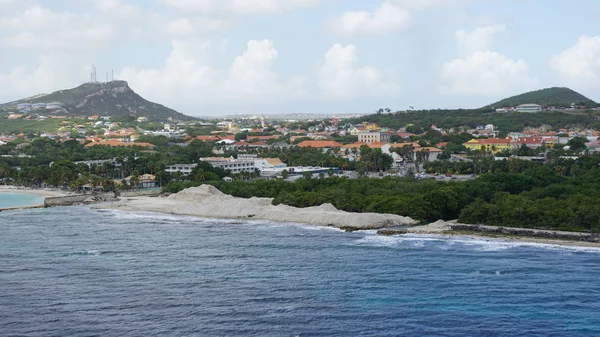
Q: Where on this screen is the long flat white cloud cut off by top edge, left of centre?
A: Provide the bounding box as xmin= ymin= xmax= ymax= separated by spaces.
xmin=160 ymin=0 xmax=321 ymax=15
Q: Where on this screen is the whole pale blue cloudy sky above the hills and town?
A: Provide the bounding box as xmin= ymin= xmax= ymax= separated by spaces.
xmin=0 ymin=0 xmax=600 ymax=116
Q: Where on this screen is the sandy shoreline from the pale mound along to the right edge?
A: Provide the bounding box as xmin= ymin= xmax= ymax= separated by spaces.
xmin=94 ymin=185 xmax=600 ymax=247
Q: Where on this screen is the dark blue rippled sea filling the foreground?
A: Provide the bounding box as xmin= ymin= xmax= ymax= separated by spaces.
xmin=0 ymin=207 xmax=600 ymax=336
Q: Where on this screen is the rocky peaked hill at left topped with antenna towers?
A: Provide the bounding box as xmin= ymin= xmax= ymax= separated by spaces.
xmin=4 ymin=81 xmax=193 ymax=121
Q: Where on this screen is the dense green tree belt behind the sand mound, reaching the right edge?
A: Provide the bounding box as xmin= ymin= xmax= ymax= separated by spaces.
xmin=166 ymin=155 xmax=600 ymax=232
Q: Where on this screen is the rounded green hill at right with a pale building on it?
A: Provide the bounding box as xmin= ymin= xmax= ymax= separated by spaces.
xmin=486 ymin=87 xmax=598 ymax=108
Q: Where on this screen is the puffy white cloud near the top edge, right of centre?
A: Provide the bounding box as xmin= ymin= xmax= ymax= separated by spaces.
xmin=329 ymin=1 xmax=410 ymax=35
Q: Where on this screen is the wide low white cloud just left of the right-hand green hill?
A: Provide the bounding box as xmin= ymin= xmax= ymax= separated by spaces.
xmin=440 ymin=51 xmax=537 ymax=97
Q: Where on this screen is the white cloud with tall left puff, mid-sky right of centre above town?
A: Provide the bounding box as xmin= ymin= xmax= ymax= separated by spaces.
xmin=318 ymin=44 xmax=400 ymax=98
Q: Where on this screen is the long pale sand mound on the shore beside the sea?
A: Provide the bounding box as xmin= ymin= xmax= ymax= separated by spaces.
xmin=99 ymin=185 xmax=416 ymax=229
